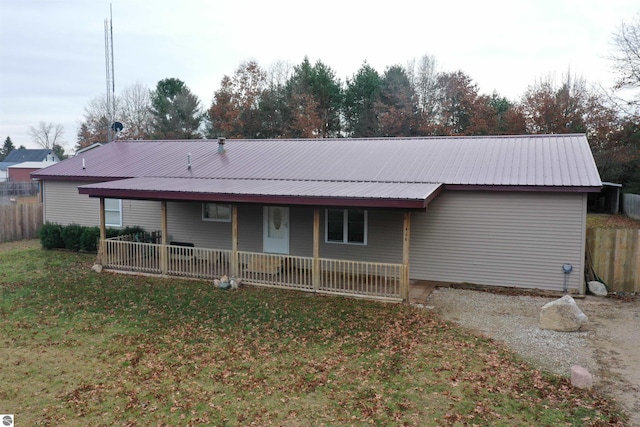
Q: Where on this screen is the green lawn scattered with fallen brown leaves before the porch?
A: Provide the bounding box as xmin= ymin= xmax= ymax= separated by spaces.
xmin=0 ymin=245 xmax=624 ymax=426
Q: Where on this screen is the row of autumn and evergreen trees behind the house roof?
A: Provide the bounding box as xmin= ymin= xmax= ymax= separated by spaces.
xmin=47 ymin=14 xmax=640 ymax=191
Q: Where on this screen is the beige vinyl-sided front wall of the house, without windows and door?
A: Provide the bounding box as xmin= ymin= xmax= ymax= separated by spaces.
xmin=43 ymin=181 xmax=587 ymax=292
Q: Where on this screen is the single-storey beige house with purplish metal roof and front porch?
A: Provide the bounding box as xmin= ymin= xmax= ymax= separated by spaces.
xmin=32 ymin=134 xmax=602 ymax=299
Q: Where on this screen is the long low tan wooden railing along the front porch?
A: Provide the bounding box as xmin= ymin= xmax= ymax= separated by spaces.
xmin=102 ymin=238 xmax=408 ymax=301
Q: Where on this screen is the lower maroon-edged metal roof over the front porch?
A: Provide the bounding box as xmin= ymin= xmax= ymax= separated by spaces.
xmin=78 ymin=177 xmax=442 ymax=209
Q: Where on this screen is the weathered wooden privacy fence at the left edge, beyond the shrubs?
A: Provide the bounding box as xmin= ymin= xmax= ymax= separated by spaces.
xmin=0 ymin=203 xmax=42 ymax=242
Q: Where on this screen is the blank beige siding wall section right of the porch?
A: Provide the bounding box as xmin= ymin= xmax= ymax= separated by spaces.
xmin=410 ymin=191 xmax=586 ymax=292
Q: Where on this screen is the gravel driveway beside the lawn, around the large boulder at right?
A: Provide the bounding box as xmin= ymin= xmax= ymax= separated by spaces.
xmin=425 ymin=288 xmax=640 ymax=426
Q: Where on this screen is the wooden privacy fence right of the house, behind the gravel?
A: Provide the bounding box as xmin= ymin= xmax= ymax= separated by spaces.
xmin=587 ymin=228 xmax=640 ymax=292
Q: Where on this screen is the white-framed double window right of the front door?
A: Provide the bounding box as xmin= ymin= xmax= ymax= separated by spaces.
xmin=325 ymin=209 xmax=367 ymax=245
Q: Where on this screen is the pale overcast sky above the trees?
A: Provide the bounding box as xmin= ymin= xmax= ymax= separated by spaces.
xmin=0 ymin=0 xmax=640 ymax=152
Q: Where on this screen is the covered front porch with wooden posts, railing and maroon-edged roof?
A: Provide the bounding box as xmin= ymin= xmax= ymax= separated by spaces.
xmin=80 ymin=180 xmax=439 ymax=302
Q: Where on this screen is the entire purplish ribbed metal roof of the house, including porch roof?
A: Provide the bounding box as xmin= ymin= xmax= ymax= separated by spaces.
xmin=32 ymin=134 xmax=602 ymax=207
